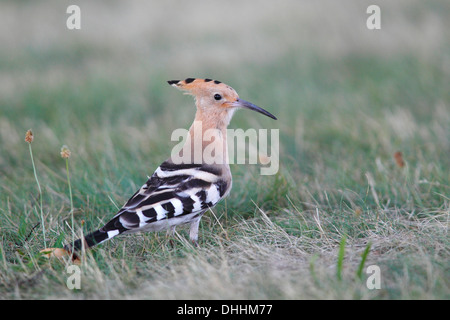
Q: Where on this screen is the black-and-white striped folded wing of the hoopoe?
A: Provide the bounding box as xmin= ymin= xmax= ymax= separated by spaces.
xmin=99 ymin=161 xmax=231 ymax=242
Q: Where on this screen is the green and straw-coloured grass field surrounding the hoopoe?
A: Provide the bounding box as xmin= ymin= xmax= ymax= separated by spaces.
xmin=0 ymin=2 xmax=450 ymax=299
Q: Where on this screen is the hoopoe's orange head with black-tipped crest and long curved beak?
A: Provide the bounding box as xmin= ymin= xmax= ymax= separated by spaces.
xmin=167 ymin=78 xmax=277 ymax=120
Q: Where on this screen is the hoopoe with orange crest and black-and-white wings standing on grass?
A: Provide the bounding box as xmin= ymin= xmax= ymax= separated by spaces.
xmin=64 ymin=78 xmax=276 ymax=253
